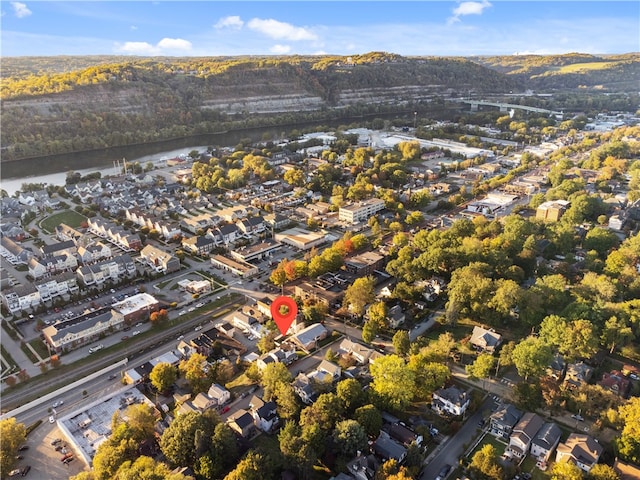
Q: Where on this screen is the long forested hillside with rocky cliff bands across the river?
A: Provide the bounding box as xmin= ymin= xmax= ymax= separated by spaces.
xmin=0 ymin=52 xmax=640 ymax=161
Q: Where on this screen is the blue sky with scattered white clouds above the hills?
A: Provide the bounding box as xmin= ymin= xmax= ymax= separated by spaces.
xmin=0 ymin=0 xmax=640 ymax=56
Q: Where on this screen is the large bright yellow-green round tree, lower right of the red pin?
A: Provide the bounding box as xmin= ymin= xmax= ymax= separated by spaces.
xmin=370 ymin=355 xmax=416 ymax=409
